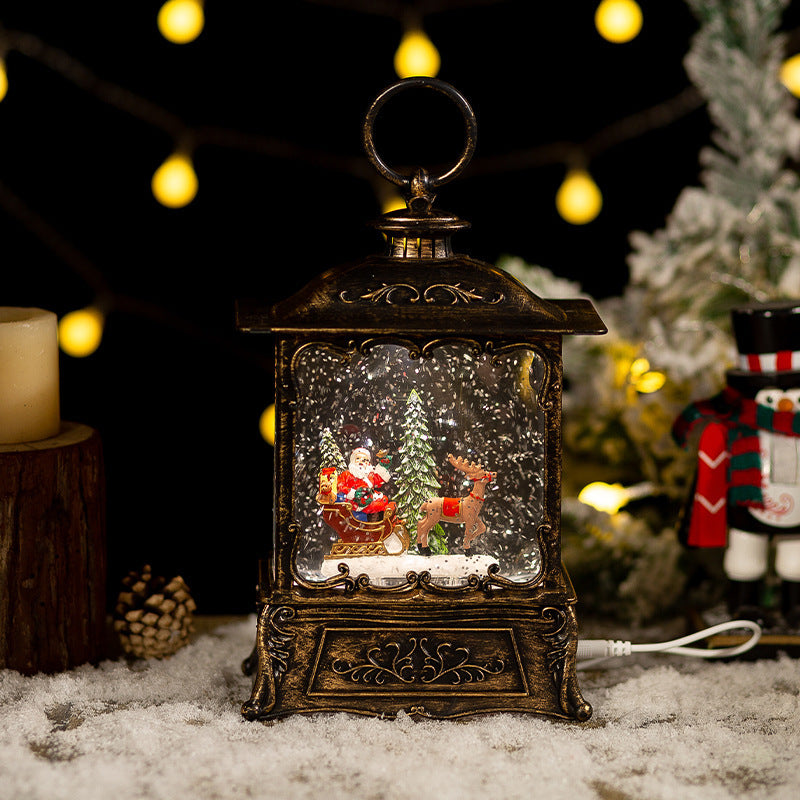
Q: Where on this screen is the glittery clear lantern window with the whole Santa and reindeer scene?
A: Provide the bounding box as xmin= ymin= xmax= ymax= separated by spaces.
xmin=294 ymin=343 xmax=545 ymax=586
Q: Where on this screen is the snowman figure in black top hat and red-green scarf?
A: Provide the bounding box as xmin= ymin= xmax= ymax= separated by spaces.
xmin=673 ymin=301 xmax=800 ymax=628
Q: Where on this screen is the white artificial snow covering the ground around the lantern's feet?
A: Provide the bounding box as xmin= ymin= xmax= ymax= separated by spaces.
xmin=0 ymin=617 xmax=800 ymax=800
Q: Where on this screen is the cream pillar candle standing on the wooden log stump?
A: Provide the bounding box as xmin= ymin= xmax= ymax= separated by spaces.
xmin=0 ymin=306 xmax=61 ymax=444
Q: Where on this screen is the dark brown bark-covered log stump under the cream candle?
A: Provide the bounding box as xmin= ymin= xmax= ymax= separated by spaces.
xmin=0 ymin=422 xmax=106 ymax=675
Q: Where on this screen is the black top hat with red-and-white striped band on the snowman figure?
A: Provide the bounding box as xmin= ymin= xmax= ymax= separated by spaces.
xmin=727 ymin=300 xmax=800 ymax=394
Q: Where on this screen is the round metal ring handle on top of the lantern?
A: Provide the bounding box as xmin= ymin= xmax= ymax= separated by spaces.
xmin=364 ymin=77 xmax=478 ymax=189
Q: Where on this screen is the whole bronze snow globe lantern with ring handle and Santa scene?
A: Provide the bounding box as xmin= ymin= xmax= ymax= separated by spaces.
xmin=238 ymin=78 xmax=605 ymax=720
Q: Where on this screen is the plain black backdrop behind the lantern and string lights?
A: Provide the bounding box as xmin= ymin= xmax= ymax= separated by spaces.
xmin=0 ymin=0 xmax=792 ymax=613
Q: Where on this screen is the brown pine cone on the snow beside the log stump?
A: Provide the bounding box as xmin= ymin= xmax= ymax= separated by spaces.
xmin=114 ymin=565 xmax=197 ymax=658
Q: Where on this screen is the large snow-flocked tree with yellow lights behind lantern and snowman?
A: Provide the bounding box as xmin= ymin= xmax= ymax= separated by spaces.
xmin=501 ymin=0 xmax=800 ymax=620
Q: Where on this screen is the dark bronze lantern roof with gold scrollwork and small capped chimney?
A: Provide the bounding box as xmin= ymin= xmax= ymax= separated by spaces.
xmin=237 ymin=225 xmax=606 ymax=336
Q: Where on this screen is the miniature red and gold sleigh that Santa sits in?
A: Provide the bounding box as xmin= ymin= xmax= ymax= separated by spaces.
xmin=317 ymin=467 xmax=410 ymax=559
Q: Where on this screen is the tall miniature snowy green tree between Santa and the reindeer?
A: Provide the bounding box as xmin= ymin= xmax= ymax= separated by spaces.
xmin=394 ymin=389 xmax=448 ymax=555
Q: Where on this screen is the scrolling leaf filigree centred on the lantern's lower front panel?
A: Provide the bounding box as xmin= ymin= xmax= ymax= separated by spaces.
xmin=331 ymin=636 xmax=506 ymax=686
